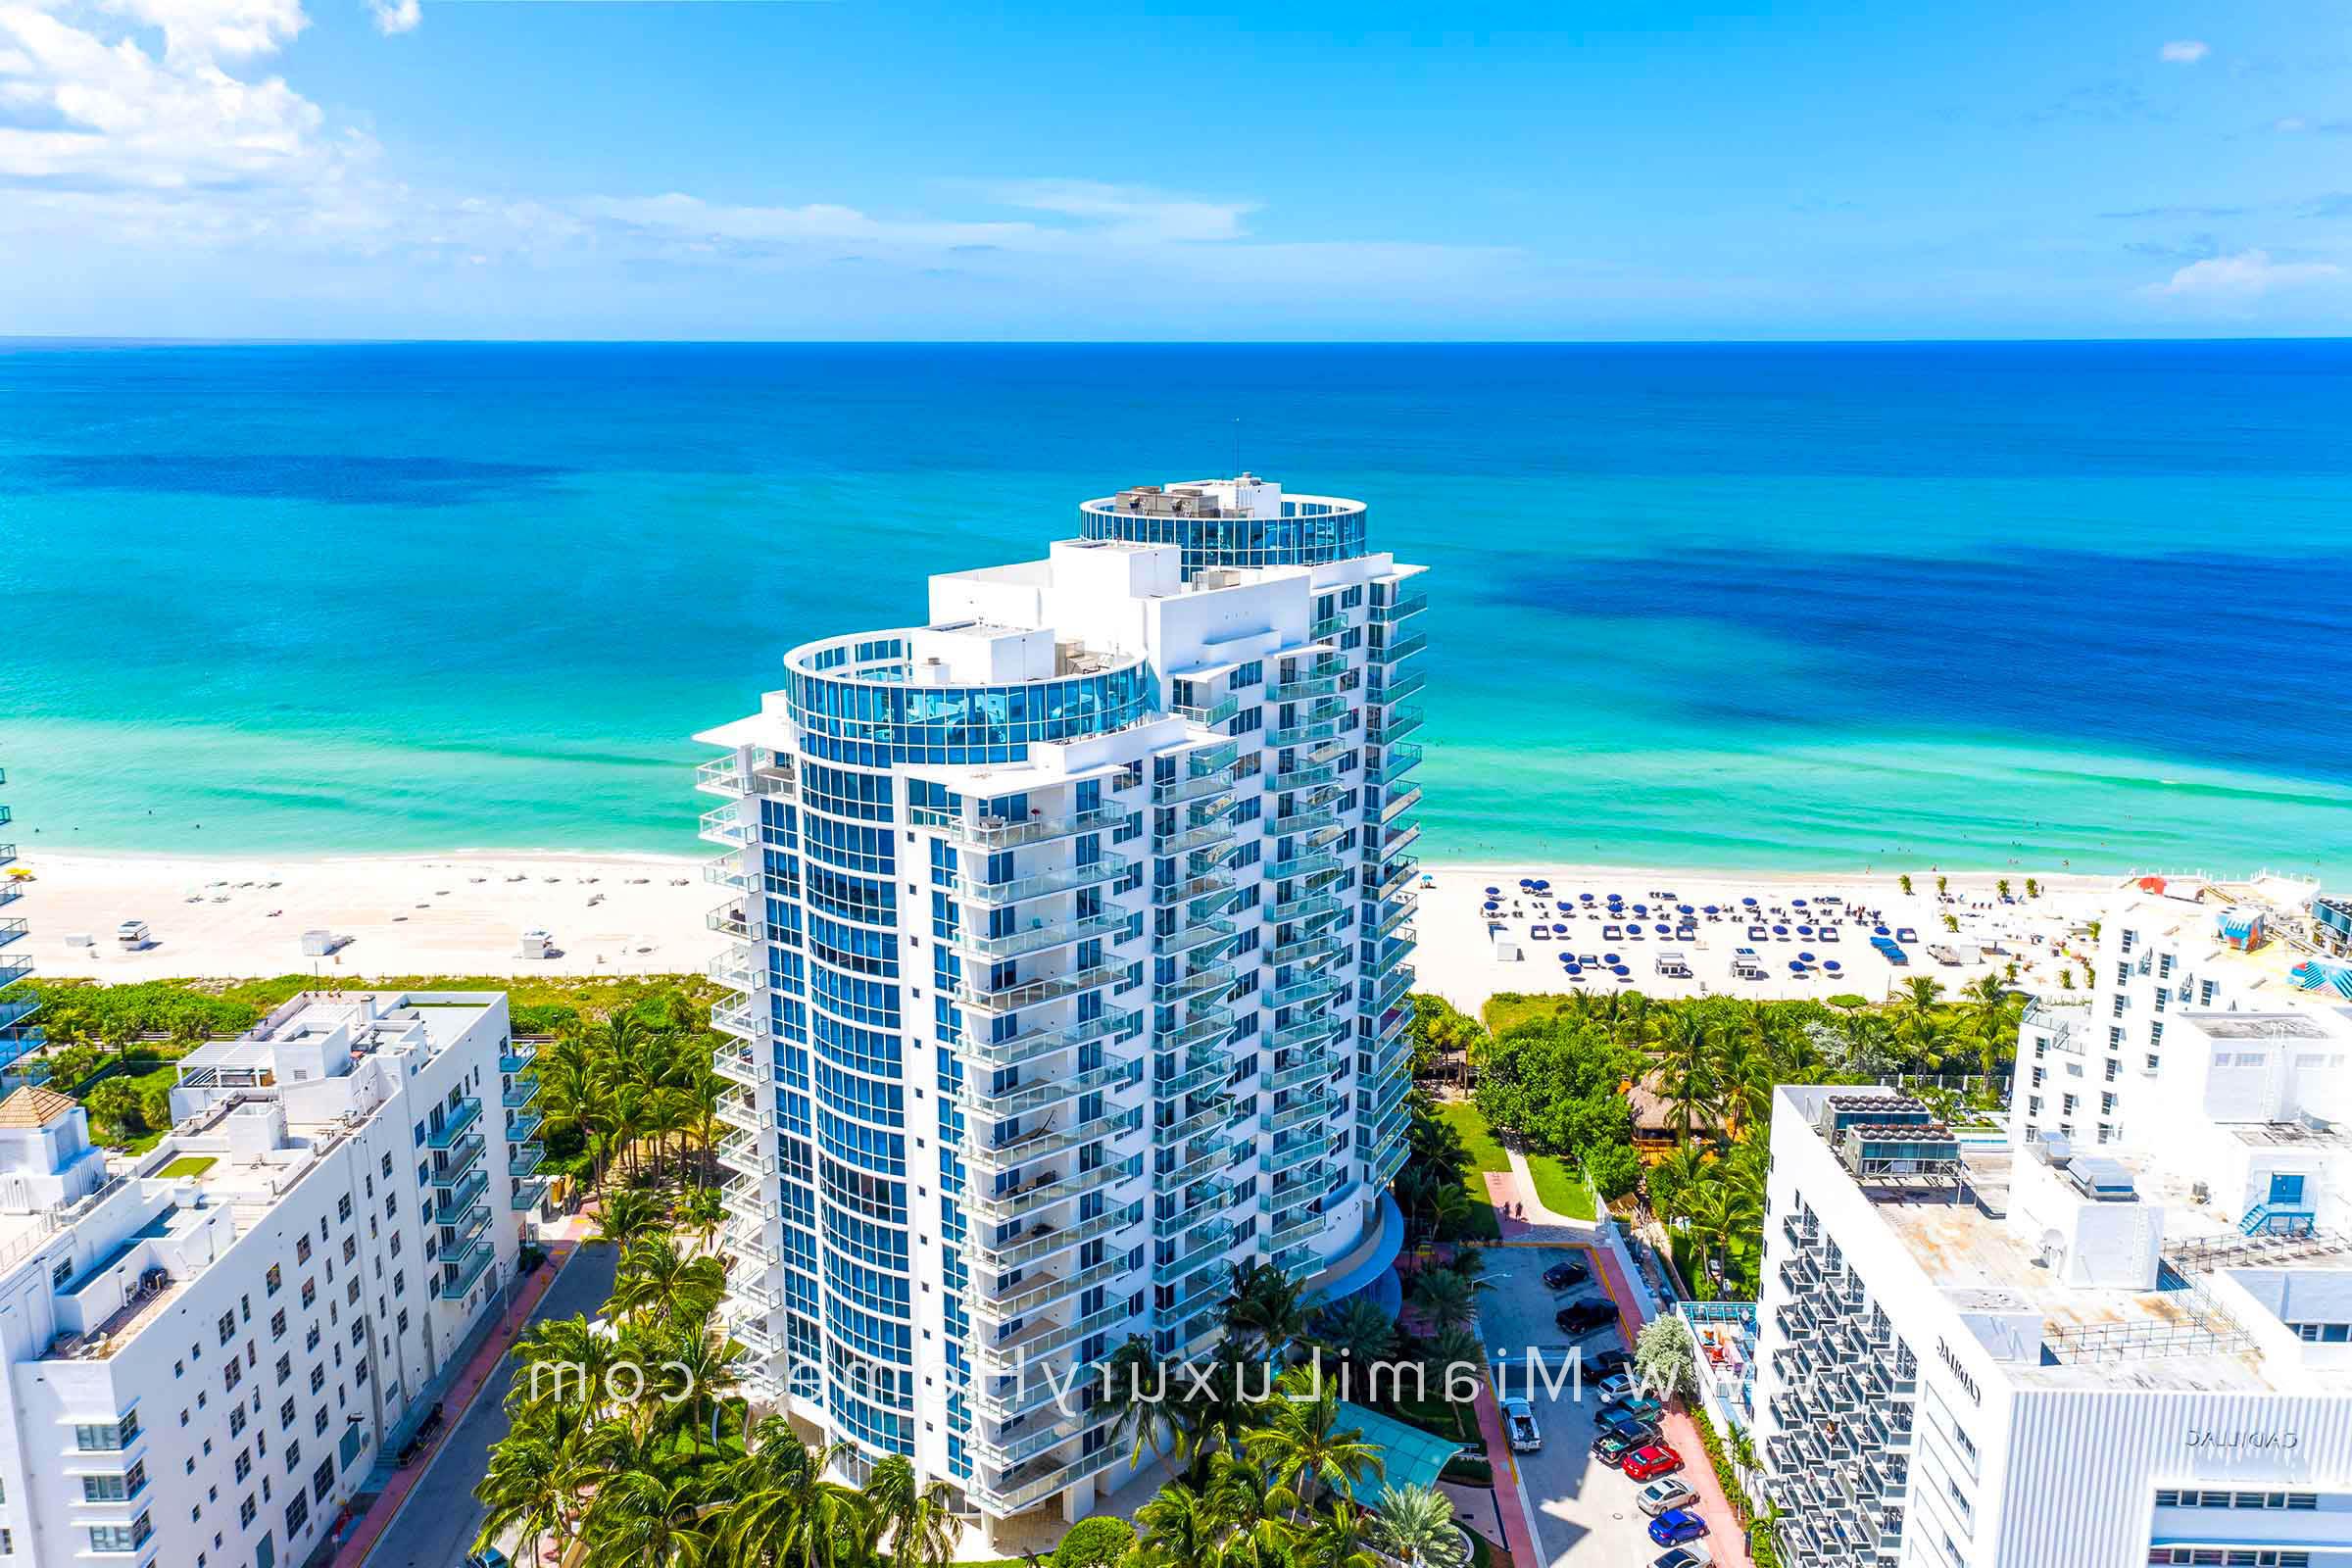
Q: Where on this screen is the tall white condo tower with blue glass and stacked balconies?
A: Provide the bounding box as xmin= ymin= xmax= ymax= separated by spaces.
xmin=701 ymin=475 xmax=1423 ymax=1519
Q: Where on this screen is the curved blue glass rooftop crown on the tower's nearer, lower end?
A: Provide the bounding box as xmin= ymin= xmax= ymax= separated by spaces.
xmin=786 ymin=637 xmax=1157 ymax=768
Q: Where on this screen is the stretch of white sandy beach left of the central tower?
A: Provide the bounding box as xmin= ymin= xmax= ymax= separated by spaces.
xmin=10 ymin=851 xmax=727 ymax=980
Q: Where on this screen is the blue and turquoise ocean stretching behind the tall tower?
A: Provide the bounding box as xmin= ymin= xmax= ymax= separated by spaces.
xmin=0 ymin=343 xmax=2352 ymax=872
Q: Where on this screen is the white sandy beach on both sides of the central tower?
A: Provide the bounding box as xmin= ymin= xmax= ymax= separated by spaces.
xmin=10 ymin=851 xmax=2122 ymax=1008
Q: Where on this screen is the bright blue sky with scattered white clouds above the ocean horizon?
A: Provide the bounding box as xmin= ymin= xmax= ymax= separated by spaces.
xmin=0 ymin=0 xmax=2352 ymax=338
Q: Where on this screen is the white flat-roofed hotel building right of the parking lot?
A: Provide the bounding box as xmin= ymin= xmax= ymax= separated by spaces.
xmin=1754 ymin=884 xmax=2352 ymax=1568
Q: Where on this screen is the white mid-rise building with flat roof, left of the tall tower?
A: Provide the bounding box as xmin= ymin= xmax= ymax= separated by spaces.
xmin=0 ymin=992 xmax=536 ymax=1568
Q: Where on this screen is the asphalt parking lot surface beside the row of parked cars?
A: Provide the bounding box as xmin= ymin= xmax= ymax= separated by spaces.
xmin=1480 ymin=1244 xmax=1660 ymax=1568
